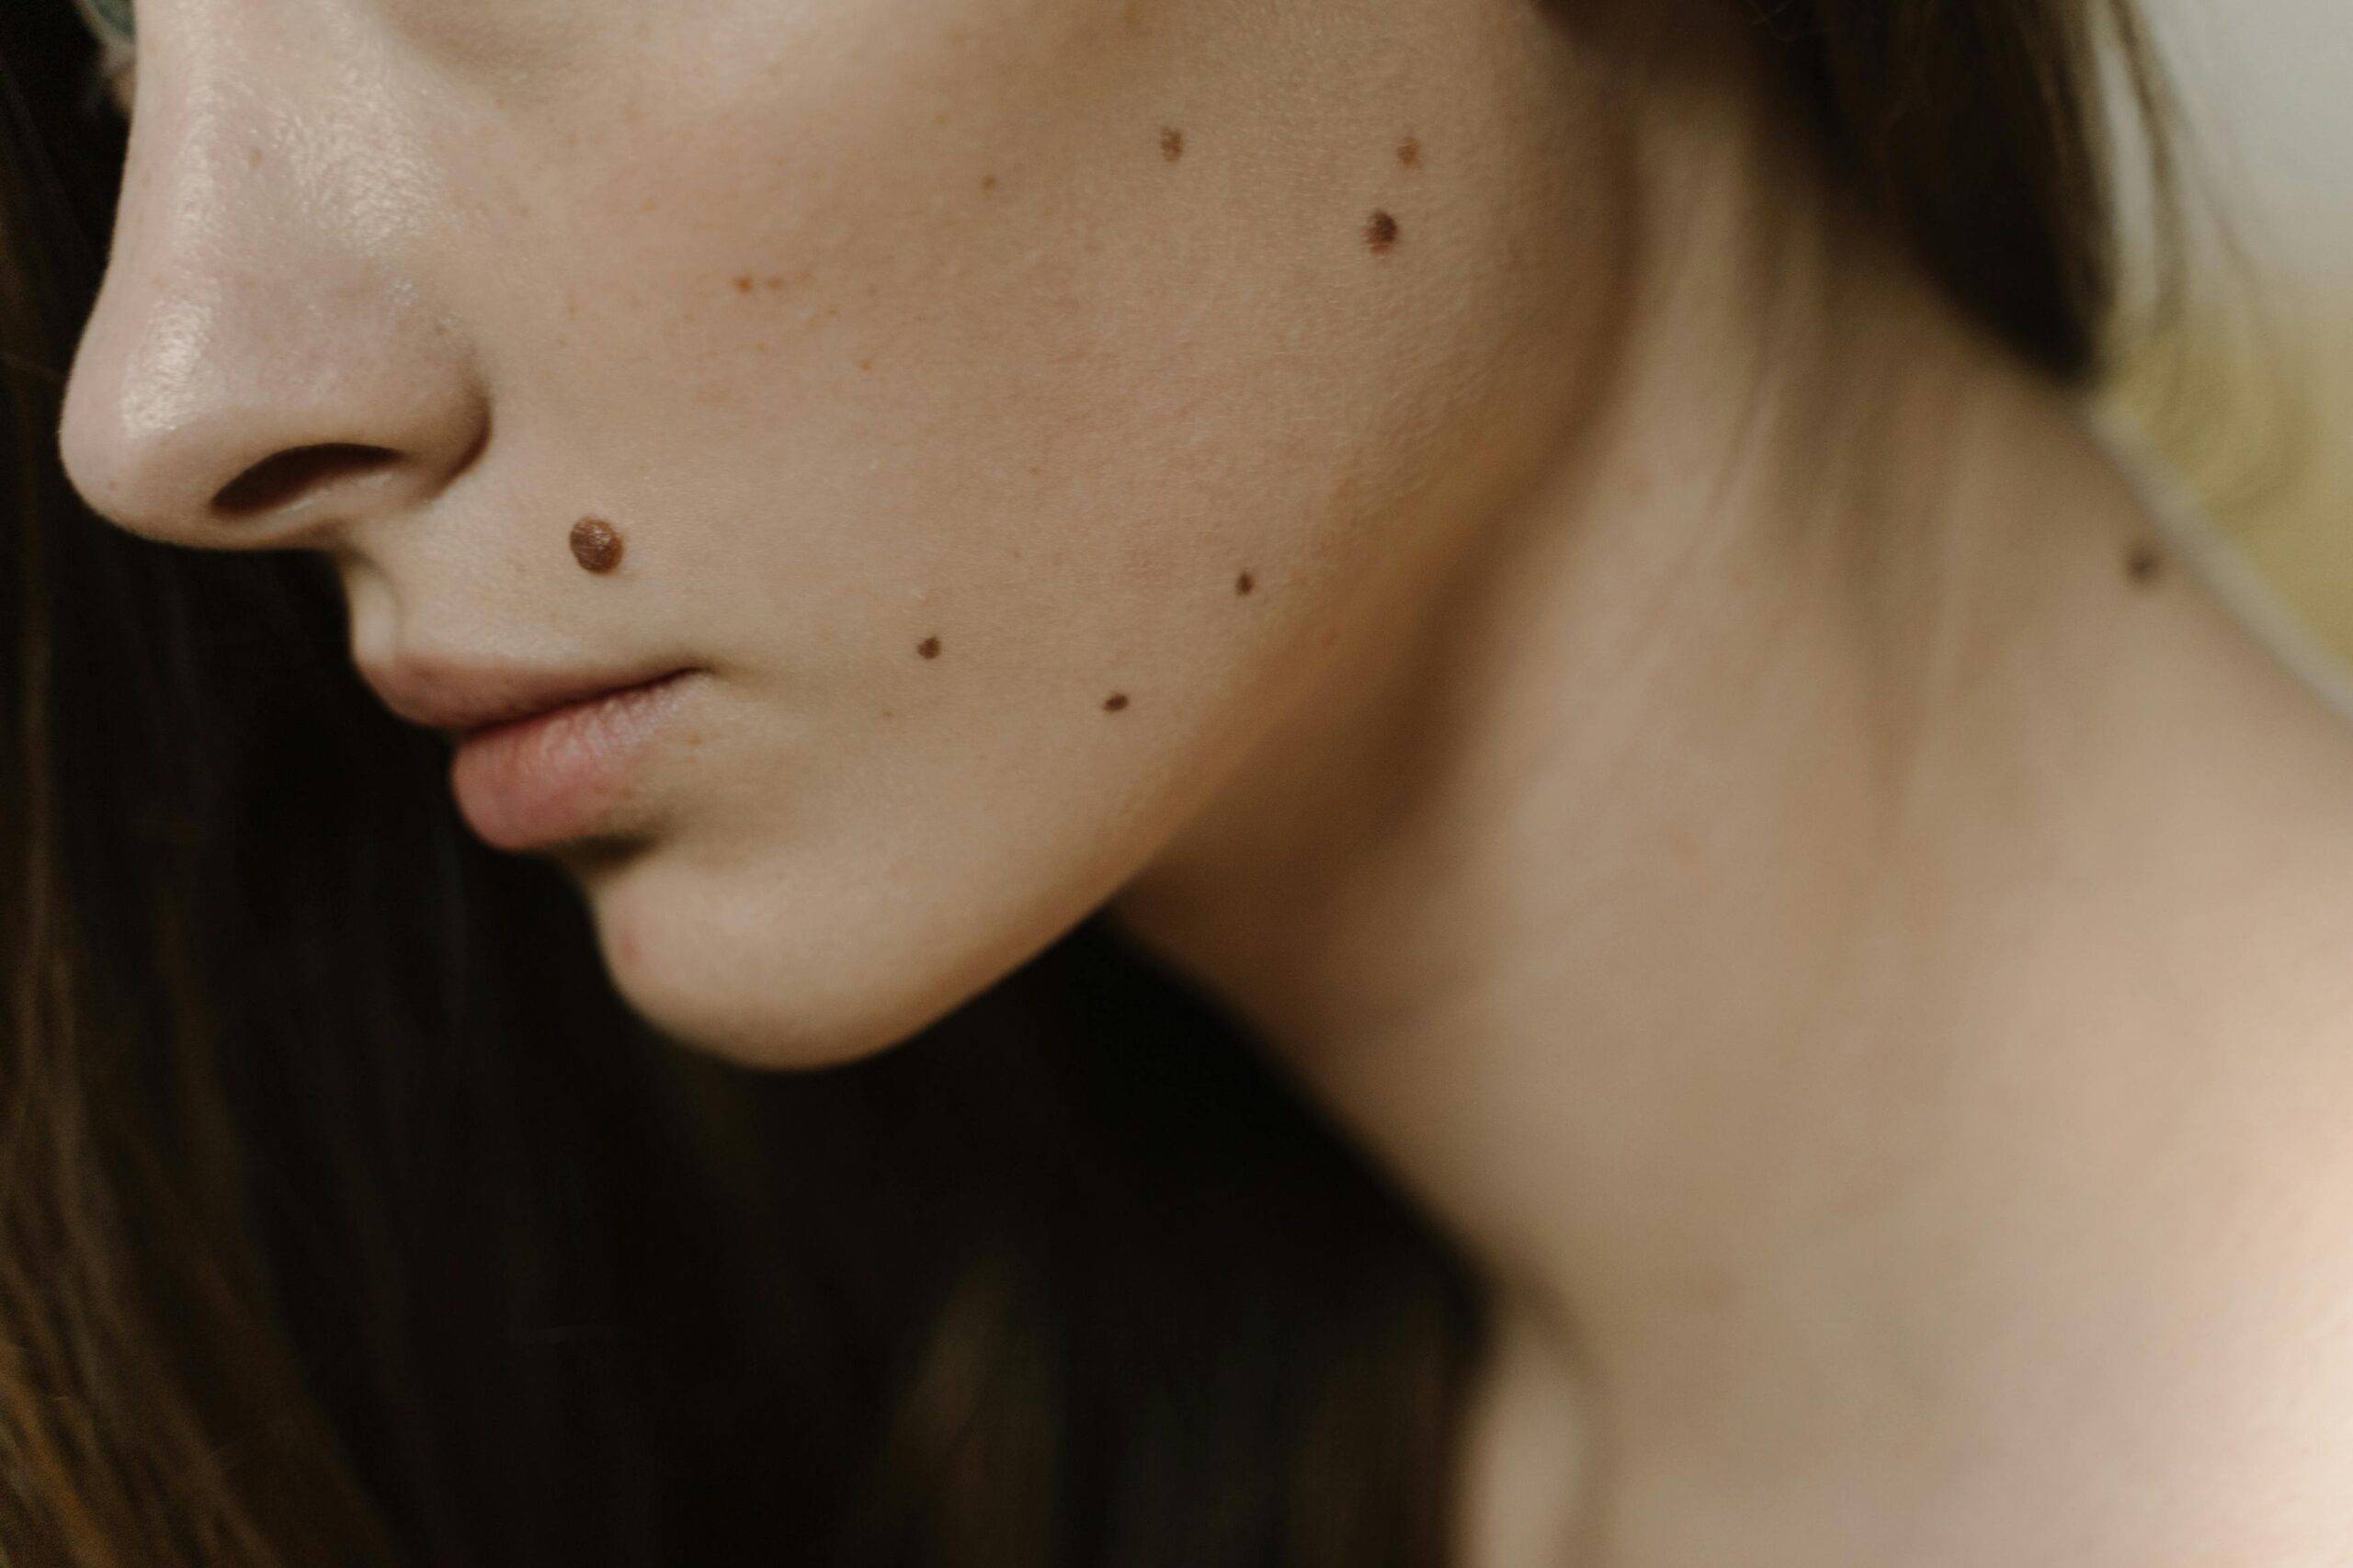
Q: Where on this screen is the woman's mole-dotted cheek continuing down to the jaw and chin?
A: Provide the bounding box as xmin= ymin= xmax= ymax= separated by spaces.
xmin=454 ymin=0 xmax=1599 ymax=1064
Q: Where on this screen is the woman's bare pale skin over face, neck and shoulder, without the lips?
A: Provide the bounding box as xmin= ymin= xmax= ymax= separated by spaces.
xmin=62 ymin=0 xmax=2353 ymax=1568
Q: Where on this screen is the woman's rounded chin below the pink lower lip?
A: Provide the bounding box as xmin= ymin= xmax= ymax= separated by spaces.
xmin=574 ymin=837 xmax=1085 ymax=1072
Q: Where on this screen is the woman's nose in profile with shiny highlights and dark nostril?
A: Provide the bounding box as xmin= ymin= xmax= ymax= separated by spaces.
xmin=59 ymin=33 xmax=489 ymax=549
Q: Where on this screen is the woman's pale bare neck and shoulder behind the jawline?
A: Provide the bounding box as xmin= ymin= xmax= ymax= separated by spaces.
xmin=1113 ymin=58 xmax=2353 ymax=1563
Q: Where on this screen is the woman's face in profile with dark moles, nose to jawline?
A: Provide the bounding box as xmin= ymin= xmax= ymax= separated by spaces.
xmin=63 ymin=0 xmax=1605 ymax=1062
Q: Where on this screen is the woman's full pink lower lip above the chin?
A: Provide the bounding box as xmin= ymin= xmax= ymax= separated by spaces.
xmin=449 ymin=671 xmax=694 ymax=850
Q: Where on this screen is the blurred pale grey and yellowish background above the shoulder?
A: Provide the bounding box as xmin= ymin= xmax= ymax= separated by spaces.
xmin=2120 ymin=0 xmax=2353 ymax=662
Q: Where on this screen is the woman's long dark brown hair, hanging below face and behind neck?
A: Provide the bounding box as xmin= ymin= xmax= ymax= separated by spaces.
xmin=0 ymin=0 xmax=2146 ymax=1568
